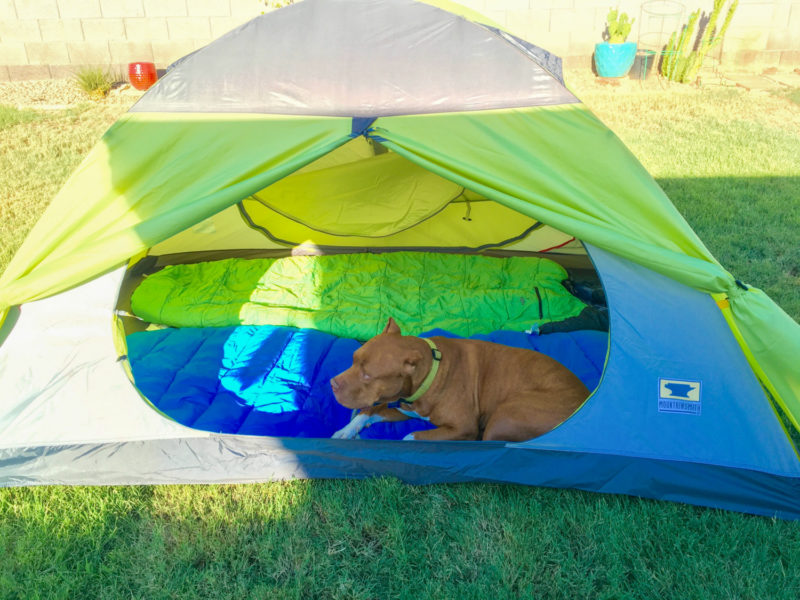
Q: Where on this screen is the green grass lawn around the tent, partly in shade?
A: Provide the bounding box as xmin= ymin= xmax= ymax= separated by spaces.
xmin=0 ymin=75 xmax=800 ymax=600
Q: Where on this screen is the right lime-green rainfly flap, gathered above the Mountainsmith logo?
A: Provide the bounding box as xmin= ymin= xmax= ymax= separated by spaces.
xmin=374 ymin=105 xmax=800 ymax=430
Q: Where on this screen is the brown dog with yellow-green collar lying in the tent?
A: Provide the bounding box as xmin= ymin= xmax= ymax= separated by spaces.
xmin=331 ymin=319 xmax=589 ymax=441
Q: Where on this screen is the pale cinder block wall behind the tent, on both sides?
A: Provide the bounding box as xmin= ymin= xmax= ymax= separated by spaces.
xmin=0 ymin=0 xmax=800 ymax=81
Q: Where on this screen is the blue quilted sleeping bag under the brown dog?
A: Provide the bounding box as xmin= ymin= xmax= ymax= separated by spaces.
xmin=127 ymin=325 xmax=608 ymax=439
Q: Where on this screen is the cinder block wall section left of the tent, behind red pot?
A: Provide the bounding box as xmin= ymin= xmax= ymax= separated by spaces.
xmin=0 ymin=0 xmax=266 ymax=81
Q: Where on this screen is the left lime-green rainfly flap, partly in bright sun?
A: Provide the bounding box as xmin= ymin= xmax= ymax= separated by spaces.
xmin=0 ymin=113 xmax=351 ymax=315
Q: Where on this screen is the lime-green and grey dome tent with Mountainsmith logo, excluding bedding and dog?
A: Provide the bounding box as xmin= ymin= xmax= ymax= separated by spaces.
xmin=0 ymin=0 xmax=800 ymax=516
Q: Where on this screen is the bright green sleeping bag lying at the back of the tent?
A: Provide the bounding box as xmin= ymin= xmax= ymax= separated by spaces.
xmin=131 ymin=252 xmax=585 ymax=340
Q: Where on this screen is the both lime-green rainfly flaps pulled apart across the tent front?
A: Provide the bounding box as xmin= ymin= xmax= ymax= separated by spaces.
xmin=0 ymin=105 xmax=800 ymax=427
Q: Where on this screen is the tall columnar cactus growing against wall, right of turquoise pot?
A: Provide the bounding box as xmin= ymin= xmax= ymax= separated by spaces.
xmin=661 ymin=0 xmax=739 ymax=83
